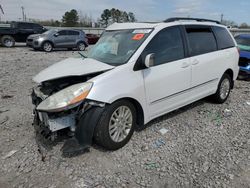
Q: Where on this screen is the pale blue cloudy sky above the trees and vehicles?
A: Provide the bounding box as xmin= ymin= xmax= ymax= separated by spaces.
xmin=0 ymin=0 xmax=250 ymax=24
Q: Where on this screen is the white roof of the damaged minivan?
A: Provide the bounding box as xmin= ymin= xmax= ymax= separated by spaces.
xmin=106 ymin=20 xmax=226 ymax=31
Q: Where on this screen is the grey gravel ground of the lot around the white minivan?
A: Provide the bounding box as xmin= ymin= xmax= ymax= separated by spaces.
xmin=0 ymin=46 xmax=250 ymax=188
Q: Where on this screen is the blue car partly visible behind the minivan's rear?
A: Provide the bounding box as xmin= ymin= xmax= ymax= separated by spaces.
xmin=235 ymin=34 xmax=250 ymax=79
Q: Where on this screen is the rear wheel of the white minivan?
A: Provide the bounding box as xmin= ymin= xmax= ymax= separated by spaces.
xmin=212 ymin=74 xmax=232 ymax=104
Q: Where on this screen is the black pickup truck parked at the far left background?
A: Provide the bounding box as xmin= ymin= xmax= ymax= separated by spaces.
xmin=0 ymin=22 xmax=47 ymax=47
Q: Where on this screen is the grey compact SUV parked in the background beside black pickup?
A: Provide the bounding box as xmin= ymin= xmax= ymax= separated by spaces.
xmin=26 ymin=29 xmax=88 ymax=52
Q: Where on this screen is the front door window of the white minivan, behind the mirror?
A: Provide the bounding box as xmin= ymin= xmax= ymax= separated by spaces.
xmin=142 ymin=27 xmax=184 ymax=65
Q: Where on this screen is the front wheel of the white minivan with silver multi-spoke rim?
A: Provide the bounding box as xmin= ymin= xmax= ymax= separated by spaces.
xmin=94 ymin=100 xmax=136 ymax=150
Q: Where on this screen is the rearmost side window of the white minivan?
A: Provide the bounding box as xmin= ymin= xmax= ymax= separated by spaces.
xmin=213 ymin=27 xmax=235 ymax=50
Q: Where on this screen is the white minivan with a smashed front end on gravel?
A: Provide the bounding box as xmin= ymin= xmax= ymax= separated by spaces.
xmin=32 ymin=18 xmax=239 ymax=152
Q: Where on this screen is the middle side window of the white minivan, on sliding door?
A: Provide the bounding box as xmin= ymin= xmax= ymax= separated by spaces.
xmin=186 ymin=26 xmax=217 ymax=56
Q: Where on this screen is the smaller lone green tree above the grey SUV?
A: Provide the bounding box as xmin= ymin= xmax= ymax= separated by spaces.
xmin=62 ymin=9 xmax=79 ymax=27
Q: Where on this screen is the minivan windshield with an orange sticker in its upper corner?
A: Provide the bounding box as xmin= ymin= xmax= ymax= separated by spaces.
xmin=88 ymin=29 xmax=152 ymax=66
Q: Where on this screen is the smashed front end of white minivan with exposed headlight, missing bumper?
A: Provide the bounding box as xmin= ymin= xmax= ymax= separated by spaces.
xmin=31 ymin=72 xmax=105 ymax=154
